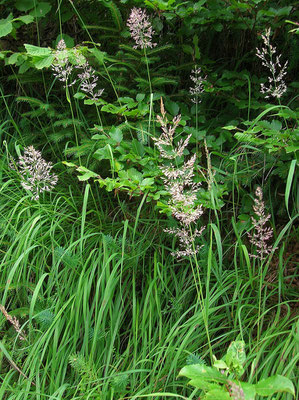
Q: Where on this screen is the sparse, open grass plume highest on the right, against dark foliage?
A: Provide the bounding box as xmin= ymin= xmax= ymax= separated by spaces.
xmin=256 ymin=28 xmax=288 ymax=99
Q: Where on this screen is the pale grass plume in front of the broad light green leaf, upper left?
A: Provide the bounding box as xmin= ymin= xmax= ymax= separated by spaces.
xmin=51 ymin=39 xmax=76 ymax=87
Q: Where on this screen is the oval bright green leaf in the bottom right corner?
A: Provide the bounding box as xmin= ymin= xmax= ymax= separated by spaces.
xmin=255 ymin=375 xmax=295 ymax=396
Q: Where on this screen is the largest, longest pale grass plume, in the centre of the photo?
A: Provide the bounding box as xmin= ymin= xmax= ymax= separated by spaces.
xmin=154 ymin=101 xmax=204 ymax=258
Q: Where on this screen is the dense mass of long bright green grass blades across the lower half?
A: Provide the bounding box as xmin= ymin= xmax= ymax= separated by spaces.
xmin=0 ymin=158 xmax=298 ymax=400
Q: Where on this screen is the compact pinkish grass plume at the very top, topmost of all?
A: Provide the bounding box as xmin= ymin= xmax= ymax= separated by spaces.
xmin=127 ymin=7 xmax=157 ymax=49
